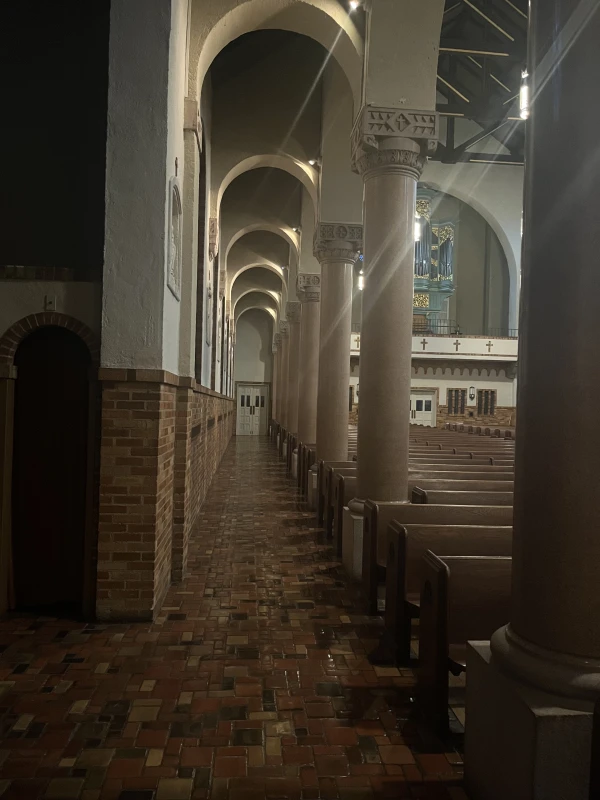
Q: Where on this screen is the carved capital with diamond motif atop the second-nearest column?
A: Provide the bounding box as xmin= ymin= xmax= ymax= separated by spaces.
xmin=351 ymin=105 xmax=439 ymax=180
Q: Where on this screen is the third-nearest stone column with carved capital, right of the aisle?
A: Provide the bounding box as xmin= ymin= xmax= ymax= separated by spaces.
xmin=315 ymin=222 xmax=363 ymax=461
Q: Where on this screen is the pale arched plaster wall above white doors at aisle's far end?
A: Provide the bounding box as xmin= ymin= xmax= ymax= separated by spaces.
xmin=234 ymin=309 xmax=273 ymax=383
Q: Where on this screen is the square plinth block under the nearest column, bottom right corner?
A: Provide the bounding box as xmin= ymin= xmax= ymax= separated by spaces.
xmin=465 ymin=642 xmax=592 ymax=800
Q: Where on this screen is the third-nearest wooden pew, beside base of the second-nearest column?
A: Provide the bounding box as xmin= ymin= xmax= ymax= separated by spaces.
xmin=362 ymin=500 xmax=513 ymax=614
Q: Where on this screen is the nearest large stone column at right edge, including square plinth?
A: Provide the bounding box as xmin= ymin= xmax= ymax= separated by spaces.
xmin=466 ymin=0 xmax=600 ymax=800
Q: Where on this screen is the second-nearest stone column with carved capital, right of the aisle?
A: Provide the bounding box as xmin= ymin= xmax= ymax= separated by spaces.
xmin=352 ymin=106 xmax=438 ymax=501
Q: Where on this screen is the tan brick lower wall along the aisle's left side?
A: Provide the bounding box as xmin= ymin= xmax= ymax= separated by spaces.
xmin=96 ymin=370 xmax=234 ymax=620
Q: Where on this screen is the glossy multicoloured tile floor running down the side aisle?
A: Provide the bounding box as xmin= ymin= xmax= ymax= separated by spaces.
xmin=0 ymin=439 xmax=466 ymax=800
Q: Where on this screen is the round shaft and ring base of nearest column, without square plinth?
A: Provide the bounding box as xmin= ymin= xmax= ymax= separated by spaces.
xmin=492 ymin=0 xmax=600 ymax=698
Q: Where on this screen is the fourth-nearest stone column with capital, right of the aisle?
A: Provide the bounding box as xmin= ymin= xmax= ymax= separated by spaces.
xmin=298 ymin=273 xmax=321 ymax=444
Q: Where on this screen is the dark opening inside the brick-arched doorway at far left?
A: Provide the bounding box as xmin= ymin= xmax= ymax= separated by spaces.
xmin=12 ymin=327 xmax=91 ymax=615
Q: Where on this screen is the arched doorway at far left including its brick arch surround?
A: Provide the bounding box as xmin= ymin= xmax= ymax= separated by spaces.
xmin=0 ymin=312 xmax=100 ymax=617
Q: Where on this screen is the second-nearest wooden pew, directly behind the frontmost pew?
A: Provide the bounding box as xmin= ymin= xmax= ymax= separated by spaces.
xmin=384 ymin=520 xmax=512 ymax=664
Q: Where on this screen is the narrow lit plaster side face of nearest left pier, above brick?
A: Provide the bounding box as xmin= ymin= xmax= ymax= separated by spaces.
xmin=163 ymin=0 xmax=191 ymax=374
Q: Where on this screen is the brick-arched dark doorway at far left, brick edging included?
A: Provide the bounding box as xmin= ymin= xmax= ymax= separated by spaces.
xmin=0 ymin=314 xmax=98 ymax=616
